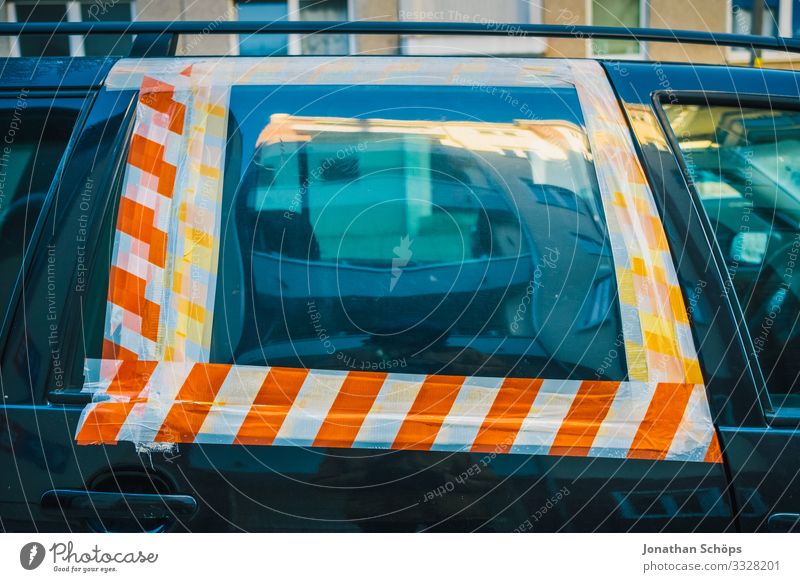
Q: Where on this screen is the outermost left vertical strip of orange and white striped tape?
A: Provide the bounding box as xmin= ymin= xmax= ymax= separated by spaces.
xmin=103 ymin=77 xmax=186 ymax=359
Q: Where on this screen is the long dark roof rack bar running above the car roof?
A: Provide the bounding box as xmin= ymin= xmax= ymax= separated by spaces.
xmin=0 ymin=21 xmax=800 ymax=53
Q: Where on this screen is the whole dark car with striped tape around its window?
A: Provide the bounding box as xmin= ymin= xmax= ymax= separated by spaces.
xmin=0 ymin=23 xmax=800 ymax=532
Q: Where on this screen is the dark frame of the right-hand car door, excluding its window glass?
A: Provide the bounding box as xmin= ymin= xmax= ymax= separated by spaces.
xmin=608 ymin=63 xmax=800 ymax=531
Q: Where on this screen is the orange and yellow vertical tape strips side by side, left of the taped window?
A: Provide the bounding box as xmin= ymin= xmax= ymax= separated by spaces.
xmin=103 ymin=68 xmax=230 ymax=361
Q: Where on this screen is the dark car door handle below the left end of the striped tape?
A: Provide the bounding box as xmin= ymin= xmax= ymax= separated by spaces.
xmin=41 ymin=489 xmax=197 ymax=520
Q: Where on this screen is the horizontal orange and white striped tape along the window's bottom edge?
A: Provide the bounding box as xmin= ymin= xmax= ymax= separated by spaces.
xmin=76 ymin=360 xmax=720 ymax=461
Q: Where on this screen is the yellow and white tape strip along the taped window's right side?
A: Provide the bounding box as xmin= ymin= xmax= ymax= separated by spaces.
xmin=570 ymin=61 xmax=703 ymax=384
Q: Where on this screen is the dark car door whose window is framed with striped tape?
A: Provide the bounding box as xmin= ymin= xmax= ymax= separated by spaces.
xmin=4 ymin=58 xmax=733 ymax=531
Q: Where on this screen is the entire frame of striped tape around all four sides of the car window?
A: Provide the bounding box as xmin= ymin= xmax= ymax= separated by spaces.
xmin=76 ymin=58 xmax=721 ymax=462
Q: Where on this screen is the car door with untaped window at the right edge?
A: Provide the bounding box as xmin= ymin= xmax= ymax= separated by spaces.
xmin=609 ymin=59 xmax=800 ymax=531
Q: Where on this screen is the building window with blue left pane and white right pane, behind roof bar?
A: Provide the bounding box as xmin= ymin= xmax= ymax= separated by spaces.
xmin=237 ymin=0 xmax=349 ymax=56
